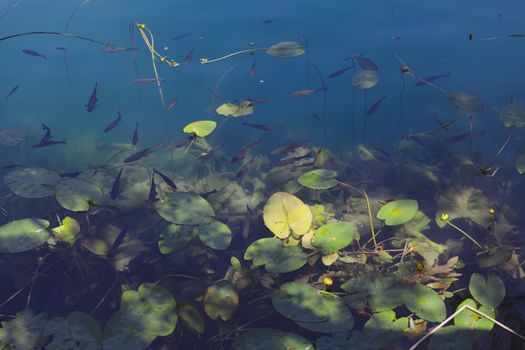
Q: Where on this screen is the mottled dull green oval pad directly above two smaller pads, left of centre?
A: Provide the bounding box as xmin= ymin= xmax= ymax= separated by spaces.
xmin=155 ymin=192 xmax=215 ymax=225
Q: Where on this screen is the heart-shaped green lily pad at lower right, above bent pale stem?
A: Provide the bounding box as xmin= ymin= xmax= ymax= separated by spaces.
xmin=468 ymin=273 xmax=505 ymax=308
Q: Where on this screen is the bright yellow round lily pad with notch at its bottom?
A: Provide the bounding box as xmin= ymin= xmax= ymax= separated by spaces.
xmin=263 ymin=192 xmax=312 ymax=239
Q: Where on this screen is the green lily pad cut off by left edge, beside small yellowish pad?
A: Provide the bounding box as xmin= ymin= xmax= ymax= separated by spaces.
xmin=0 ymin=219 xmax=49 ymax=253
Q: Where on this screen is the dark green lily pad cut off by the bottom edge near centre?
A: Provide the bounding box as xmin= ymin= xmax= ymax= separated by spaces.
xmin=232 ymin=328 xmax=314 ymax=350
